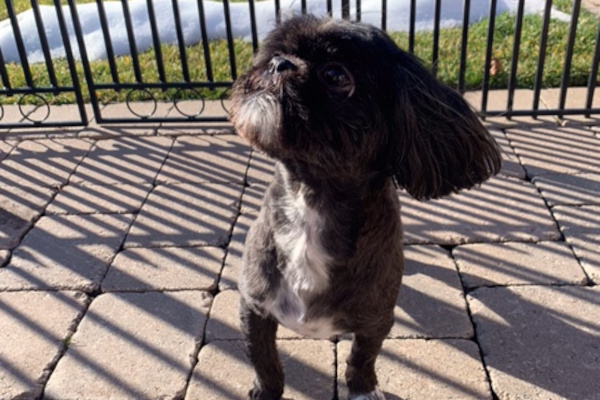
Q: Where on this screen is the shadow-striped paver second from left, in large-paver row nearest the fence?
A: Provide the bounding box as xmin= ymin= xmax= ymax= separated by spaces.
xmin=70 ymin=136 xmax=173 ymax=184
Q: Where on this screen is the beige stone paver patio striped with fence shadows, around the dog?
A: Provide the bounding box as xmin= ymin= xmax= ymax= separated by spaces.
xmin=0 ymin=97 xmax=600 ymax=400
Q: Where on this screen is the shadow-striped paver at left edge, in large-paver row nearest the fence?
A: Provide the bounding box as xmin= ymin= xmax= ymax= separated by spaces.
xmin=0 ymin=138 xmax=92 ymax=187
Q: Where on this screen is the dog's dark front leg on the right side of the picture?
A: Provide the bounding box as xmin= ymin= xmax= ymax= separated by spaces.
xmin=346 ymin=334 xmax=385 ymax=400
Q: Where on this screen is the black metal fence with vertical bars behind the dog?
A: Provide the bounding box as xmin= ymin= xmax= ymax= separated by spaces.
xmin=0 ymin=0 xmax=600 ymax=128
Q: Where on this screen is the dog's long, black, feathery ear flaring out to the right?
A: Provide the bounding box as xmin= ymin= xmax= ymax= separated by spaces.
xmin=389 ymin=51 xmax=502 ymax=200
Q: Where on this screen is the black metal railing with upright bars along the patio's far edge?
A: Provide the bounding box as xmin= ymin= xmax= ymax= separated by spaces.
xmin=0 ymin=0 xmax=600 ymax=128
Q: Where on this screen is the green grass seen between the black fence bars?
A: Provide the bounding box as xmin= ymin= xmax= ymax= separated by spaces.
xmin=0 ymin=0 xmax=598 ymax=104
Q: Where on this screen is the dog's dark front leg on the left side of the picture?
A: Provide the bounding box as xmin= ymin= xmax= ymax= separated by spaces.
xmin=240 ymin=300 xmax=284 ymax=400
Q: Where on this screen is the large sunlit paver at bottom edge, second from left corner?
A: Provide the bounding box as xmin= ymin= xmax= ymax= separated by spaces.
xmin=44 ymin=291 xmax=211 ymax=399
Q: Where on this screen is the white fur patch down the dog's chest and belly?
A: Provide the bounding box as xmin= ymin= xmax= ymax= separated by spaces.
xmin=265 ymin=191 xmax=339 ymax=338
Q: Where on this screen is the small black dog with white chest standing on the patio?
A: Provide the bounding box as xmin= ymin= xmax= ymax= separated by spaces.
xmin=230 ymin=16 xmax=501 ymax=400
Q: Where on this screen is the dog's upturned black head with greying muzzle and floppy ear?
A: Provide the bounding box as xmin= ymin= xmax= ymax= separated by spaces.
xmin=231 ymin=16 xmax=501 ymax=199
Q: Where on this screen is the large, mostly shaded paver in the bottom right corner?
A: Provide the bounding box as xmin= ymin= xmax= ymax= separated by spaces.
xmin=469 ymin=286 xmax=600 ymax=400
